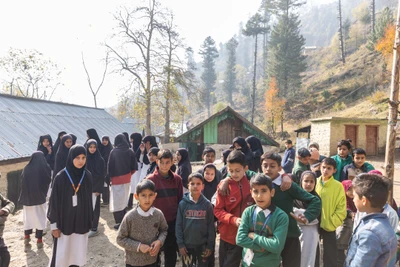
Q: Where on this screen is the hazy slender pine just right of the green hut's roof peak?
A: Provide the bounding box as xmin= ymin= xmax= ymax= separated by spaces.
xmin=223 ymin=37 xmax=239 ymax=106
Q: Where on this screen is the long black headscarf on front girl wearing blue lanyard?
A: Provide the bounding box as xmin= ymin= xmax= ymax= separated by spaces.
xmin=47 ymin=145 xmax=93 ymax=235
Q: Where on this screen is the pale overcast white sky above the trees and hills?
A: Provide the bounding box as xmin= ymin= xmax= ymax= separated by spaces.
xmin=0 ymin=0 xmax=329 ymax=107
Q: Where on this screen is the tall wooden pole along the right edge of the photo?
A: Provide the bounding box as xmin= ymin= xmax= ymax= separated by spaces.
xmin=385 ymin=0 xmax=400 ymax=205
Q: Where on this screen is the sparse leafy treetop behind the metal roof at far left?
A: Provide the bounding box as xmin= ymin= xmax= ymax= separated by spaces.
xmin=0 ymin=48 xmax=61 ymax=100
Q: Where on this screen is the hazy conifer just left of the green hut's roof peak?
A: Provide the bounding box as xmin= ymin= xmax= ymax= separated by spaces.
xmin=199 ymin=36 xmax=218 ymax=117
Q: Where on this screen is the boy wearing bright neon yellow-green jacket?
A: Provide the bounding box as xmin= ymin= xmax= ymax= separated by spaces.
xmin=315 ymin=158 xmax=347 ymax=267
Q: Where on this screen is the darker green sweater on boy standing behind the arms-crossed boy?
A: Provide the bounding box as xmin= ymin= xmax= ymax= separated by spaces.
xmin=272 ymin=180 xmax=321 ymax=237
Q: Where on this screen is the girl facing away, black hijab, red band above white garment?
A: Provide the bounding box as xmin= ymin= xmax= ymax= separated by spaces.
xmin=107 ymin=134 xmax=137 ymax=229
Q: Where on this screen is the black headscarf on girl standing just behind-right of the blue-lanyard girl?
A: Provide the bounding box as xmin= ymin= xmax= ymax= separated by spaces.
xmin=86 ymin=139 xmax=105 ymax=193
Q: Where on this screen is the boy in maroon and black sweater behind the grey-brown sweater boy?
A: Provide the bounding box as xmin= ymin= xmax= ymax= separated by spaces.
xmin=147 ymin=149 xmax=183 ymax=267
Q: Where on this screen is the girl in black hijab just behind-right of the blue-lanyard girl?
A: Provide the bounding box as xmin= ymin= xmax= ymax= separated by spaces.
xmin=86 ymin=139 xmax=105 ymax=237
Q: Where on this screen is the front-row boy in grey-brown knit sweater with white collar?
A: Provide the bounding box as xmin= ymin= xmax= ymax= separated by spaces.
xmin=117 ymin=179 xmax=168 ymax=267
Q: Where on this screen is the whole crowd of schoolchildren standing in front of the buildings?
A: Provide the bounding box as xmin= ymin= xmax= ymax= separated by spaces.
xmin=0 ymin=134 xmax=398 ymax=267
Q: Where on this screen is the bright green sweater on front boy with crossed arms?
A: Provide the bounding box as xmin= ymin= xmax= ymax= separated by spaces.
xmin=236 ymin=205 xmax=289 ymax=267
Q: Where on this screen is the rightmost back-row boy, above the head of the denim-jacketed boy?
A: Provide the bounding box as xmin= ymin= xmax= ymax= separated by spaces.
xmin=340 ymin=148 xmax=375 ymax=181
